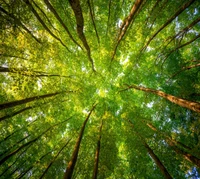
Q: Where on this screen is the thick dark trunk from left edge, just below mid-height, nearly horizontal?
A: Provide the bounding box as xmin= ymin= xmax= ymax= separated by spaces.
xmin=0 ymin=91 xmax=71 ymax=110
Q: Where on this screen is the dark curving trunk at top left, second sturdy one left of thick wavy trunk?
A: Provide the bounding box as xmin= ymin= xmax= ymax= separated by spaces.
xmin=25 ymin=0 xmax=70 ymax=52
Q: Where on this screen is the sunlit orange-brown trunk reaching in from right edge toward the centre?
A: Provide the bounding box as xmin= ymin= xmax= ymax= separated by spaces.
xmin=123 ymin=85 xmax=200 ymax=113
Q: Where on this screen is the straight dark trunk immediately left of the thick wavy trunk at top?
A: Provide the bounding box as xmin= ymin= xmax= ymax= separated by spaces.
xmin=44 ymin=0 xmax=82 ymax=49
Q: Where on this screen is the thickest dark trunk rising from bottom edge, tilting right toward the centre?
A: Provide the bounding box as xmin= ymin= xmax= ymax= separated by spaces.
xmin=64 ymin=105 xmax=96 ymax=179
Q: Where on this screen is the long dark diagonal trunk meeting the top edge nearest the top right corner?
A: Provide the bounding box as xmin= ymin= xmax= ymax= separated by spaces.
xmin=140 ymin=0 xmax=195 ymax=52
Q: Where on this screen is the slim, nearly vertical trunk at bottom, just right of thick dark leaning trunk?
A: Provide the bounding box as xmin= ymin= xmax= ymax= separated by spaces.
xmin=92 ymin=120 xmax=103 ymax=179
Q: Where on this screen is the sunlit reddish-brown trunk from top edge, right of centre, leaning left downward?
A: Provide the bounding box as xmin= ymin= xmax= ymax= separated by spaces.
xmin=111 ymin=0 xmax=143 ymax=62
